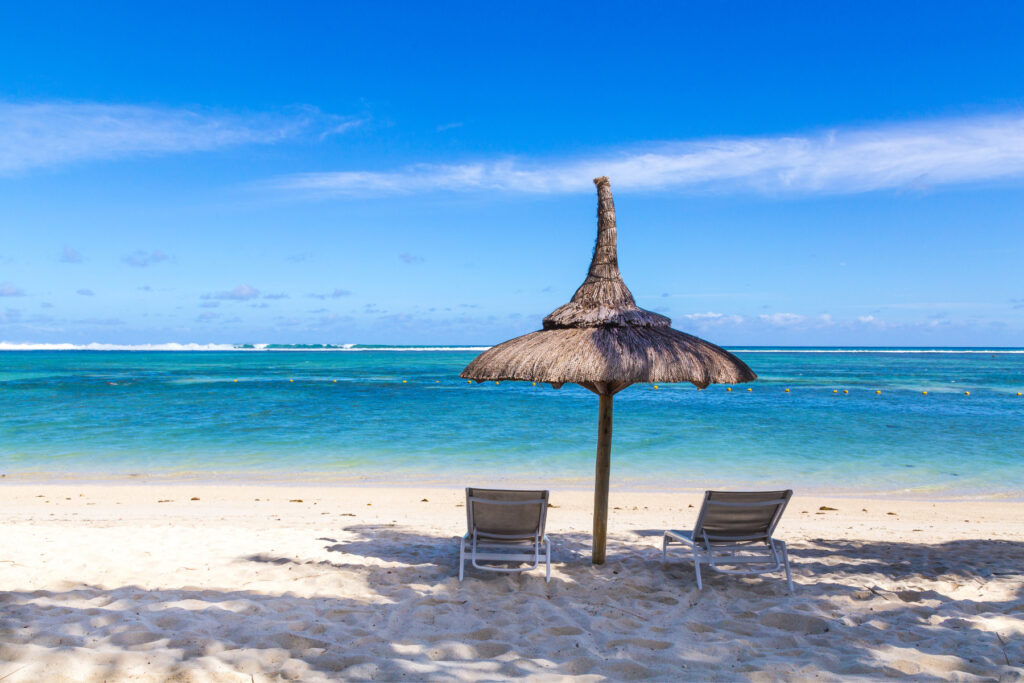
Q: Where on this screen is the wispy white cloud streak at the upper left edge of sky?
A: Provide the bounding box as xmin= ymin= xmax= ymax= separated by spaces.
xmin=0 ymin=101 xmax=358 ymax=175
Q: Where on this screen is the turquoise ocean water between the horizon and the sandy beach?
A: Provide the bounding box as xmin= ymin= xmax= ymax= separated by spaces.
xmin=0 ymin=345 xmax=1024 ymax=499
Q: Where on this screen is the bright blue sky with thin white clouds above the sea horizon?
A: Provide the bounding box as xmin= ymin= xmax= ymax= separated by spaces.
xmin=0 ymin=2 xmax=1024 ymax=346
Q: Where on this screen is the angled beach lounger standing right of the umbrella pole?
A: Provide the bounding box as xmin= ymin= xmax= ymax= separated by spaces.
xmin=662 ymin=490 xmax=793 ymax=591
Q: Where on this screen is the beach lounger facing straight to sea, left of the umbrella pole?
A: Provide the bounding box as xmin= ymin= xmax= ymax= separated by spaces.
xmin=459 ymin=488 xmax=551 ymax=582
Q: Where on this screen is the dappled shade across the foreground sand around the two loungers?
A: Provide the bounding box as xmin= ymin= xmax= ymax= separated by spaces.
xmin=0 ymin=524 xmax=1024 ymax=683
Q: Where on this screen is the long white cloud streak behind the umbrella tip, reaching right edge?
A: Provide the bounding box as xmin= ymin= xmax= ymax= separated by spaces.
xmin=272 ymin=113 xmax=1024 ymax=197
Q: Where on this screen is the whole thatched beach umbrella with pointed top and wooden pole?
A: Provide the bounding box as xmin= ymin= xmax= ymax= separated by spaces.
xmin=461 ymin=176 xmax=757 ymax=564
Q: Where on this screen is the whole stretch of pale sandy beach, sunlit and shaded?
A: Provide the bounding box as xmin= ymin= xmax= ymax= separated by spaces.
xmin=0 ymin=482 xmax=1024 ymax=683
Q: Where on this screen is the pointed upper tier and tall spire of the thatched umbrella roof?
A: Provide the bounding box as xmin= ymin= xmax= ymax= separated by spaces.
xmin=544 ymin=175 xmax=672 ymax=330
